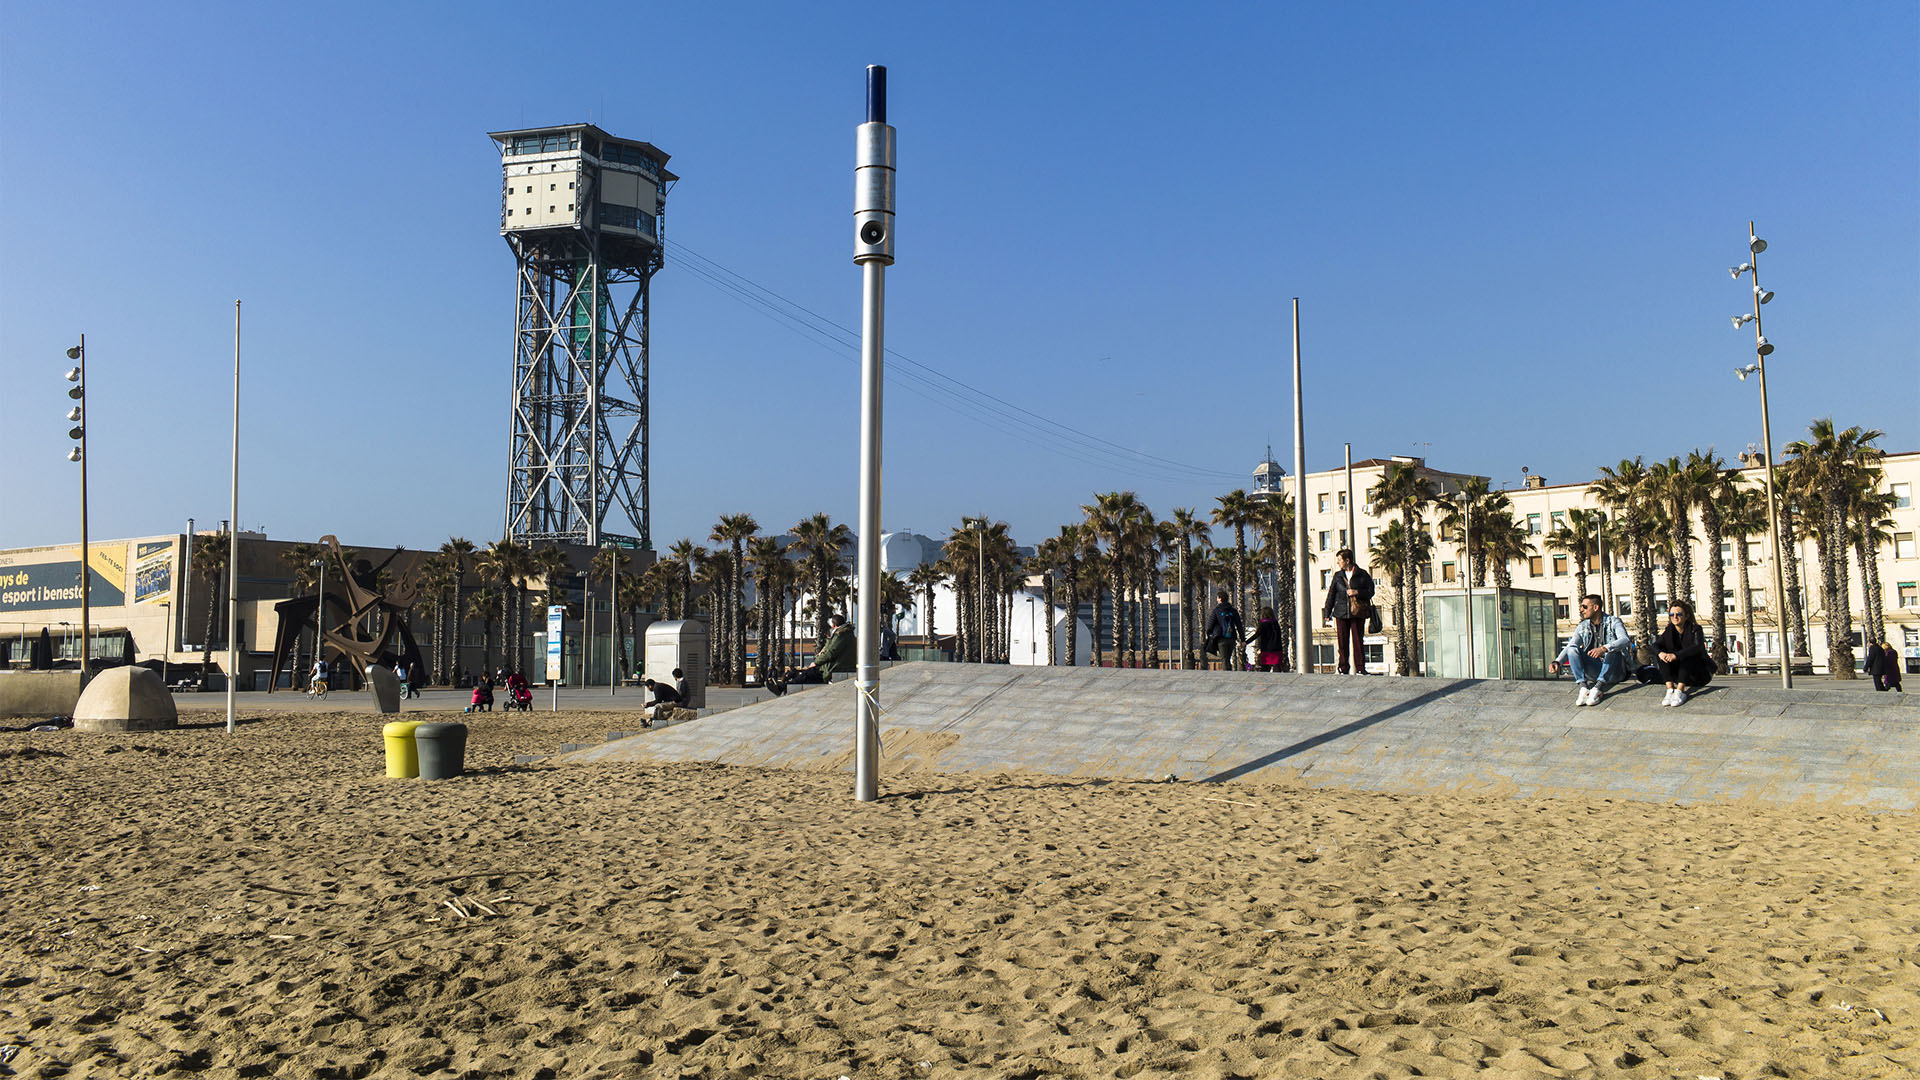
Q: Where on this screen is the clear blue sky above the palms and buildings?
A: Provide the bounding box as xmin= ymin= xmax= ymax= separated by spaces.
xmin=0 ymin=2 xmax=1920 ymax=546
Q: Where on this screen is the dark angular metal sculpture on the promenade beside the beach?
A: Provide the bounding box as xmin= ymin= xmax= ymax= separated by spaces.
xmin=267 ymin=536 xmax=426 ymax=694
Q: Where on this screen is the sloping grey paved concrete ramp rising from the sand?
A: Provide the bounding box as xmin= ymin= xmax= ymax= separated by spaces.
xmin=561 ymin=663 xmax=1920 ymax=809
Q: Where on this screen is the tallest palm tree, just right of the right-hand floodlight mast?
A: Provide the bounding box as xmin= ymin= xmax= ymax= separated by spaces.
xmin=1788 ymin=417 xmax=1884 ymax=678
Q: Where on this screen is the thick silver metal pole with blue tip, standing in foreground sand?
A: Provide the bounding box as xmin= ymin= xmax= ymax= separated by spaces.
xmin=852 ymin=63 xmax=895 ymax=803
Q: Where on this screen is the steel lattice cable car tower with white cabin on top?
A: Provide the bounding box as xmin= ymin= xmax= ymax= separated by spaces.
xmin=492 ymin=123 xmax=680 ymax=548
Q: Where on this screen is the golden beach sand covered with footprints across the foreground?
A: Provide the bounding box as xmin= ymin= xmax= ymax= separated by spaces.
xmin=0 ymin=713 xmax=1920 ymax=1080
